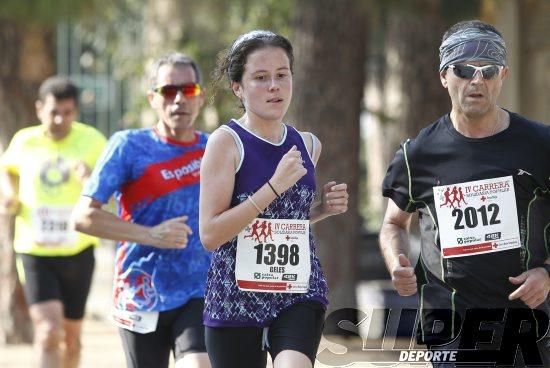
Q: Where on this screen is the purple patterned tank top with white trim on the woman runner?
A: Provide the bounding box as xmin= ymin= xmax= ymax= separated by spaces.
xmin=204 ymin=120 xmax=328 ymax=327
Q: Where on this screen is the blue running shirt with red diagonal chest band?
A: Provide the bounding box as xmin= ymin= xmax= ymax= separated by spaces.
xmin=83 ymin=128 xmax=210 ymax=311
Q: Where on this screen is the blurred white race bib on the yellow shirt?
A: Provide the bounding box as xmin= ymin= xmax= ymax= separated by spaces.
xmin=32 ymin=206 xmax=77 ymax=247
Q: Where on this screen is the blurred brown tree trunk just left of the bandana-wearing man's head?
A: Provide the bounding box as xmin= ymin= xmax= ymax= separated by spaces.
xmin=386 ymin=0 xmax=451 ymax=142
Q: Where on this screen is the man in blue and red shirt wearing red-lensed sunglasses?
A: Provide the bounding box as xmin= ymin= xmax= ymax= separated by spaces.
xmin=73 ymin=53 xmax=210 ymax=367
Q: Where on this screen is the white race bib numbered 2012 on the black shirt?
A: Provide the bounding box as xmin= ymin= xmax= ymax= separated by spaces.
xmin=433 ymin=176 xmax=521 ymax=258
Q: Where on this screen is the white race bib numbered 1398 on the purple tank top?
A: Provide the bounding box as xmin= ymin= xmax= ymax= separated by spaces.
xmin=235 ymin=218 xmax=311 ymax=293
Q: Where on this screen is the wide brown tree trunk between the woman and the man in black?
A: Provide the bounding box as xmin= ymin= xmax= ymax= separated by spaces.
xmin=290 ymin=0 xmax=367 ymax=316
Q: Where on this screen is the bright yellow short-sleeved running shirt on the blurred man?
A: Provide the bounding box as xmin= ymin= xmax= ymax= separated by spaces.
xmin=0 ymin=122 xmax=106 ymax=256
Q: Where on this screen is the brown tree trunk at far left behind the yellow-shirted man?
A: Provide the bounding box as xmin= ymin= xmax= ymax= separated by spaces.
xmin=0 ymin=19 xmax=54 ymax=343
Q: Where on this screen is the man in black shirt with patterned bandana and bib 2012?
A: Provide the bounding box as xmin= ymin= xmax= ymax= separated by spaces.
xmin=380 ymin=21 xmax=550 ymax=367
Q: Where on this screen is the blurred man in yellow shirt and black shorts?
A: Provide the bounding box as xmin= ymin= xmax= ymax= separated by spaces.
xmin=0 ymin=76 xmax=105 ymax=367
